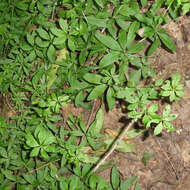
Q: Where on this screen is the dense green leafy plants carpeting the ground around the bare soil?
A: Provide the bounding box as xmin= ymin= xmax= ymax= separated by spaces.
xmin=0 ymin=0 xmax=190 ymax=190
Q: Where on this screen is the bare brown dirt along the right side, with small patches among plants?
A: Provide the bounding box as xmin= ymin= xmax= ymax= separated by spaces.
xmin=64 ymin=17 xmax=190 ymax=190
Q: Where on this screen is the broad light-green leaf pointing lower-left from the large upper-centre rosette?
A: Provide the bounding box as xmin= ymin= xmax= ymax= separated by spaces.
xmin=99 ymin=51 xmax=120 ymax=68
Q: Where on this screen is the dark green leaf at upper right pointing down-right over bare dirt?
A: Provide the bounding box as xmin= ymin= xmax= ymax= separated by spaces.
xmin=158 ymin=29 xmax=176 ymax=51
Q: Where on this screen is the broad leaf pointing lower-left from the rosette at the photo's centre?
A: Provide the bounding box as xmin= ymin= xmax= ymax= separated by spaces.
xmin=87 ymin=84 xmax=107 ymax=101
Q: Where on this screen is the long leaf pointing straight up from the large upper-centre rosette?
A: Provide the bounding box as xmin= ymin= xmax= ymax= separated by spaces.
xmin=126 ymin=21 xmax=140 ymax=48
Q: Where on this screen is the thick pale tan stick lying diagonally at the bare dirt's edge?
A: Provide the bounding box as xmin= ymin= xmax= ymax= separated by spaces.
xmin=92 ymin=119 xmax=137 ymax=172
